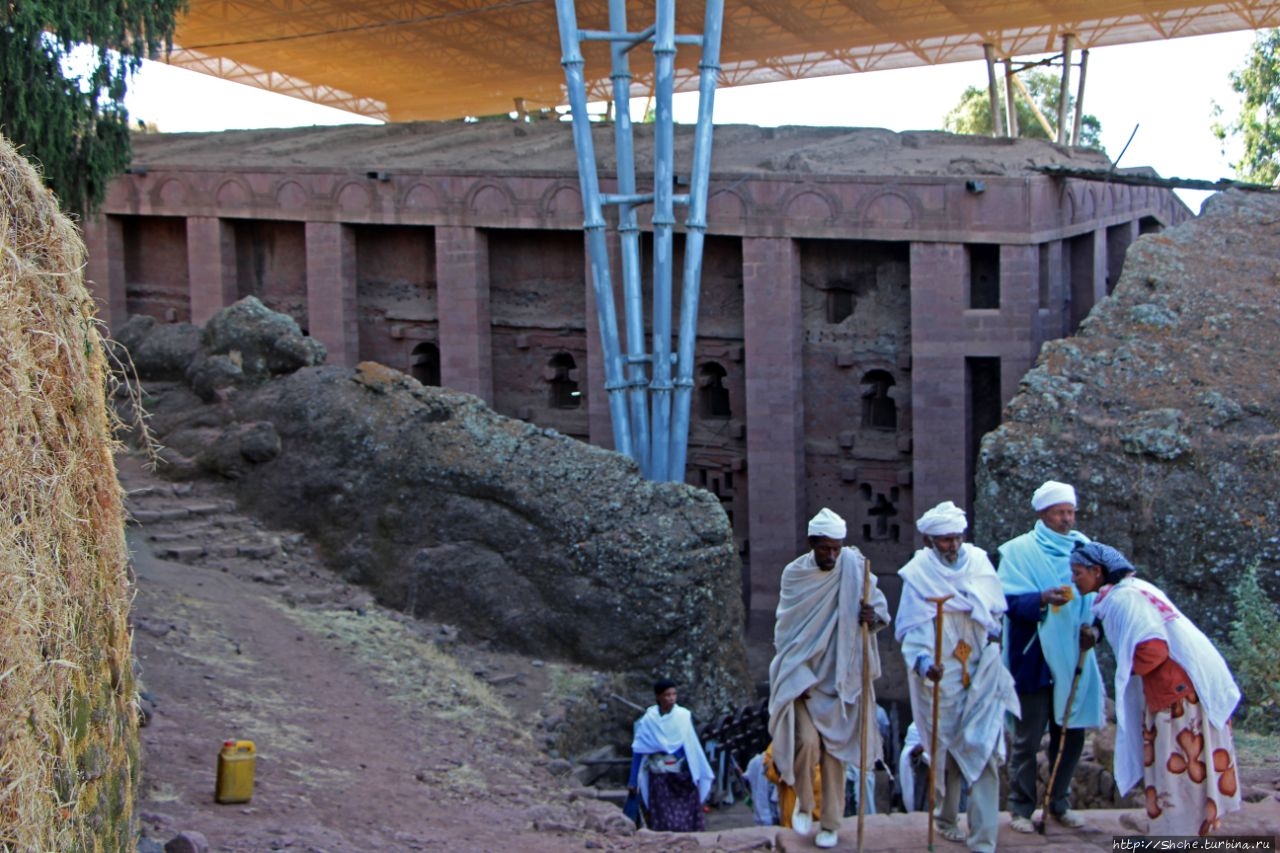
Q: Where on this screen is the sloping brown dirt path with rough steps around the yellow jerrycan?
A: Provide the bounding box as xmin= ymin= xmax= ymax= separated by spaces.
xmin=120 ymin=460 xmax=637 ymax=853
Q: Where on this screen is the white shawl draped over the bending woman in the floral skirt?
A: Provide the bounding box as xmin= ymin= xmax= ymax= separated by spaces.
xmin=1093 ymin=575 xmax=1240 ymax=797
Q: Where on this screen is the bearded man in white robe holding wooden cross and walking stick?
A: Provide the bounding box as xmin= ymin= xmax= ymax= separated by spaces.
xmin=895 ymin=501 xmax=1019 ymax=853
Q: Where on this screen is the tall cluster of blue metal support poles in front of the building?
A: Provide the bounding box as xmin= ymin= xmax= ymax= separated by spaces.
xmin=556 ymin=0 xmax=724 ymax=480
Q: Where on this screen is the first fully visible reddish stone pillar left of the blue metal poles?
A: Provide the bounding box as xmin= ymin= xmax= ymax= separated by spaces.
xmin=435 ymin=225 xmax=493 ymax=405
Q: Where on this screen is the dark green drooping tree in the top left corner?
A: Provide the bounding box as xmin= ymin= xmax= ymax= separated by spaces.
xmin=0 ymin=0 xmax=187 ymax=215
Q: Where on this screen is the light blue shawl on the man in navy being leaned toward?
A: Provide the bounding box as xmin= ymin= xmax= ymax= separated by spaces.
xmin=997 ymin=521 xmax=1103 ymax=729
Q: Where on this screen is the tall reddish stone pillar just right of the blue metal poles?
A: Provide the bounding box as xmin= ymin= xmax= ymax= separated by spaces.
xmin=742 ymin=237 xmax=806 ymax=614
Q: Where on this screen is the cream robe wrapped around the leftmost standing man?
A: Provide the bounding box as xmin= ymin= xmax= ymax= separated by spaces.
xmin=769 ymin=547 xmax=890 ymax=786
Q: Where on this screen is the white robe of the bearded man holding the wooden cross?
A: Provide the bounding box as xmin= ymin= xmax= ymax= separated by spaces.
xmin=896 ymin=543 xmax=1021 ymax=785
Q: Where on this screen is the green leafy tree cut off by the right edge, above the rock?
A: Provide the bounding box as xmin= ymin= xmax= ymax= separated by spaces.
xmin=1213 ymin=29 xmax=1280 ymax=183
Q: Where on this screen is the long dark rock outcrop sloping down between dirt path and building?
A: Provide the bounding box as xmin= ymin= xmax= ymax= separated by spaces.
xmin=117 ymin=306 xmax=750 ymax=719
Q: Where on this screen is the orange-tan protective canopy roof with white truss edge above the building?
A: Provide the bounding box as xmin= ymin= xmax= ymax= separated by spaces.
xmin=169 ymin=0 xmax=1280 ymax=122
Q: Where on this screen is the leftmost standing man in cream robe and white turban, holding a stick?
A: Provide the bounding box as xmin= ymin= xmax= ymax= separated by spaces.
xmin=769 ymin=508 xmax=890 ymax=848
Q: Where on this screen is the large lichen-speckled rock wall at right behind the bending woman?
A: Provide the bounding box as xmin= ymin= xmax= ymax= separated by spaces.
xmin=974 ymin=192 xmax=1280 ymax=630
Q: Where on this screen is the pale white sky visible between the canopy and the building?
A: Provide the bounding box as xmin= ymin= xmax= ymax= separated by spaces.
xmin=127 ymin=32 xmax=1253 ymax=210
